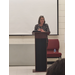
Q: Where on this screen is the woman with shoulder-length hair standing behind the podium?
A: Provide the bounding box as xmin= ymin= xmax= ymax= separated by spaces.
xmin=34 ymin=16 xmax=50 ymax=46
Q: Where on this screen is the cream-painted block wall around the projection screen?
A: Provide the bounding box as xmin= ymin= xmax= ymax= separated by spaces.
xmin=9 ymin=0 xmax=65 ymax=64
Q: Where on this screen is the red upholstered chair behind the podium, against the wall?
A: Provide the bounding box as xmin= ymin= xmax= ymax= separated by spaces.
xmin=47 ymin=39 xmax=62 ymax=63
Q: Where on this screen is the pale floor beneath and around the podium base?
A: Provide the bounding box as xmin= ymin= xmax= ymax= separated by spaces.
xmin=9 ymin=65 xmax=50 ymax=75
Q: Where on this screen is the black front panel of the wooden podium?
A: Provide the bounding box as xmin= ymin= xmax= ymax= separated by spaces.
xmin=35 ymin=38 xmax=47 ymax=71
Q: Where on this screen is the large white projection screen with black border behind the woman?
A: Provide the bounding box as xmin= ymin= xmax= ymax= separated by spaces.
xmin=9 ymin=0 xmax=58 ymax=35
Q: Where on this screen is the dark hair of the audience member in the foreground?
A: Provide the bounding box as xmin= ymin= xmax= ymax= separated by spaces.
xmin=46 ymin=58 xmax=65 ymax=75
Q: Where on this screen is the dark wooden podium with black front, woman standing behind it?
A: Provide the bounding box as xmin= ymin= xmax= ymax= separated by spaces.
xmin=32 ymin=32 xmax=49 ymax=72
